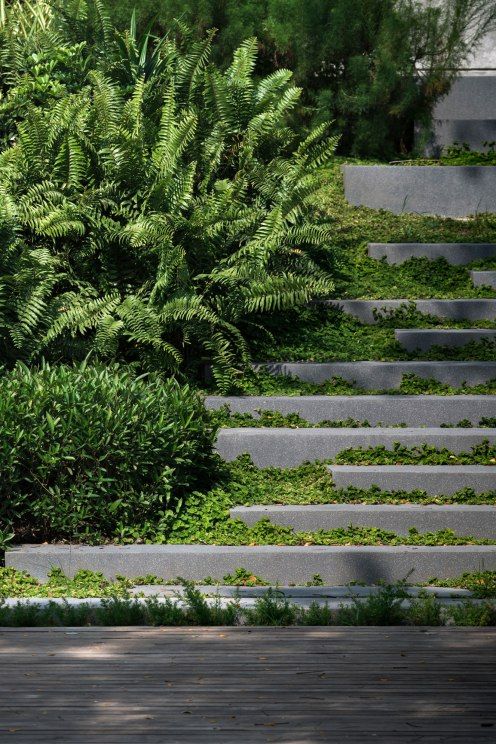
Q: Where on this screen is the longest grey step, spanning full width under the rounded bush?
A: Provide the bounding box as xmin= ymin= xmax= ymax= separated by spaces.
xmin=5 ymin=545 xmax=496 ymax=584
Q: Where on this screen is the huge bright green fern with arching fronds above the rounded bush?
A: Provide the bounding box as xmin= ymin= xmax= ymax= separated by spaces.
xmin=0 ymin=19 xmax=336 ymax=389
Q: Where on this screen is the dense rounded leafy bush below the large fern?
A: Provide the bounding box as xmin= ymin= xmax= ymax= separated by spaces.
xmin=0 ymin=365 xmax=217 ymax=541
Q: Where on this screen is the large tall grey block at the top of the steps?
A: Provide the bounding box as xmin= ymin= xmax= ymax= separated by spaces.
xmin=343 ymin=165 xmax=496 ymax=217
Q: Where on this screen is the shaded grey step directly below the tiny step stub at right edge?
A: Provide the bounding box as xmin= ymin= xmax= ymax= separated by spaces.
xmin=325 ymin=300 xmax=496 ymax=324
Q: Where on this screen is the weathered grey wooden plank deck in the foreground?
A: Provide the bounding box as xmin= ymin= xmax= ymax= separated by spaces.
xmin=0 ymin=628 xmax=496 ymax=744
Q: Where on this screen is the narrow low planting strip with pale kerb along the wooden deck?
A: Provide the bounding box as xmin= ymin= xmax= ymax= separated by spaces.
xmin=0 ymin=581 xmax=496 ymax=627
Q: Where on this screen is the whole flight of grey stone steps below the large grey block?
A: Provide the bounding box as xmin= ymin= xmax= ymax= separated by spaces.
xmin=6 ymin=244 xmax=496 ymax=586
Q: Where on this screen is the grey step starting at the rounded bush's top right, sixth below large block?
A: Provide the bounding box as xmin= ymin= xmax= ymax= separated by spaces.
xmin=205 ymin=395 xmax=496 ymax=426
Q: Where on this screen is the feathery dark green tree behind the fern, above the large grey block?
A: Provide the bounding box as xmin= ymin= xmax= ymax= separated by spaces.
xmin=102 ymin=0 xmax=496 ymax=158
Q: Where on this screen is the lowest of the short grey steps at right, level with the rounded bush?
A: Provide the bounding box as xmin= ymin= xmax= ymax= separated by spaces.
xmin=329 ymin=465 xmax=496 ymax=496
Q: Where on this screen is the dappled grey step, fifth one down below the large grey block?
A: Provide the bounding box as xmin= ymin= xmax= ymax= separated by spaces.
xmin=255 ymin=361 xmax=496 ymax=390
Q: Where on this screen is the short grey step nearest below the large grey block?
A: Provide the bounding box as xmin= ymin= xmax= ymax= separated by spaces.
xmin=368 ymin=243 xmax=496 ymax=265
